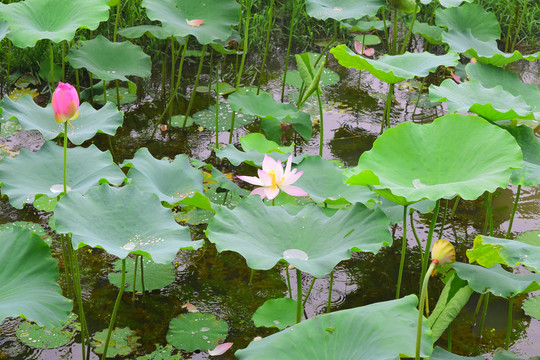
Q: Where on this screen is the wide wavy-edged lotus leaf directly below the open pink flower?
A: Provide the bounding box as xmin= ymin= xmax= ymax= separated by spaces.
xmin=207 ymin=195 xmax=392 ymax=278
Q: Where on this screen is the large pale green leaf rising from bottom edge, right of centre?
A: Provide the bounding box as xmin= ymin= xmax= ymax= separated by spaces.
xmin=235 ymin=295 xmax=433 ymax=360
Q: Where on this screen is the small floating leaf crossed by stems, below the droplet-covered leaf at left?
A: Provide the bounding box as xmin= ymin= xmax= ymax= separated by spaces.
xmin=109 ymin=259 xmax=175 ymax=292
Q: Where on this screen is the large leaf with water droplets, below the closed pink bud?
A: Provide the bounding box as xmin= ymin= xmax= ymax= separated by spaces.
xmin=55 ymin=185 xmax=201 ymax=264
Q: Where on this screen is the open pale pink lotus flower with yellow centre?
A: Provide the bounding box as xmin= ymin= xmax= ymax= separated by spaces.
xmin=238 ymin=154 xmax=308 ymax=200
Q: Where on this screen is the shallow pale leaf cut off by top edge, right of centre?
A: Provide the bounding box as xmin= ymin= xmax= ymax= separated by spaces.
xmin=306 ymin=0 xmax=385 ymax=20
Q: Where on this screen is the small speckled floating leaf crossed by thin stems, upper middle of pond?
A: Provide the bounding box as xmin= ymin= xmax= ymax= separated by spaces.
xmin=189 ymin=103 xmax=255 ymax=131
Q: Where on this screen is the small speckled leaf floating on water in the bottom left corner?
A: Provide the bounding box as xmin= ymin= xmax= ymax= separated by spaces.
xmin=17 ymin=313 xmax=80 ymax=349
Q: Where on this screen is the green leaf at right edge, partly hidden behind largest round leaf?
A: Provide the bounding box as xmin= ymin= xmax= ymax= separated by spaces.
xmin=502 ymin=126 xmax=540 ymax=186
